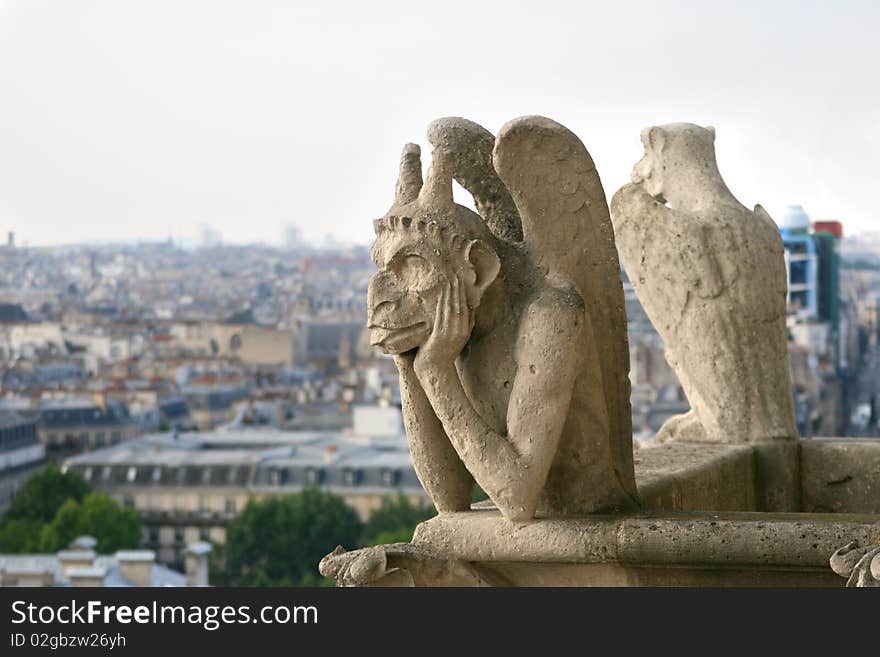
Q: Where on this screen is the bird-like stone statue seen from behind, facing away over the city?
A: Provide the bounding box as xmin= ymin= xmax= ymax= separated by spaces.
xmin=611 ymin=123 xmax=797 ymax=443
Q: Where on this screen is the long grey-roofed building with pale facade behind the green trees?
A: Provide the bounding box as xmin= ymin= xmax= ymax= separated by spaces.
xmin=64 ymin=414 xmax=427 ymax=566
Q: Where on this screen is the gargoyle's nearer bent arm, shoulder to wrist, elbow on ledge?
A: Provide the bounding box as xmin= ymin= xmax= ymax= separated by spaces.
xmin=418 ymin=294 xmax=589 ymax=520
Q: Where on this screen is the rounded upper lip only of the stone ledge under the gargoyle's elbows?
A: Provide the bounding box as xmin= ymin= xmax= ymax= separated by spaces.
xmin=413 ymin=509 xmax=880 ymax=570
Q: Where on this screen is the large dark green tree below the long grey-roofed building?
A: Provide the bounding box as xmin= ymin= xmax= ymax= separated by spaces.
xmin=224 ymin=488 xmax=361 ymax=586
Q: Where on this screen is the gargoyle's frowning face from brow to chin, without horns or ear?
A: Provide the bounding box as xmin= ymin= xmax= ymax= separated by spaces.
xmin=367 ymin=234 xmax=455 ymax=354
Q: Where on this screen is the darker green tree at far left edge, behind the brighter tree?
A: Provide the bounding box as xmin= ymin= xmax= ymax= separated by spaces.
xmin=0 ymin=464 xmax=92 ymax=553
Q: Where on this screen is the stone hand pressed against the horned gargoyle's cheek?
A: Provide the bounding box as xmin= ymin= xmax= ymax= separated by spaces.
xmin=414 ymin=276 xmax=473 ymax=374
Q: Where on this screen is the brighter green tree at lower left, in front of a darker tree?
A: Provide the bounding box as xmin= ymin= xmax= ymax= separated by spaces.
xmin=40 ymin=493 xmax=143 ymax=554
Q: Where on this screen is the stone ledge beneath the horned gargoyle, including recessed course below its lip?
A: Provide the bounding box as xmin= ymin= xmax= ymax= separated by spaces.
xmin=413 ymin=509 xmax=880 ymax=586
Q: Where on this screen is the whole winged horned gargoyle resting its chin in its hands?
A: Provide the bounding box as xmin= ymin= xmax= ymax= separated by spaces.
xmin=368 ymin=117 xmax=638 ymax=520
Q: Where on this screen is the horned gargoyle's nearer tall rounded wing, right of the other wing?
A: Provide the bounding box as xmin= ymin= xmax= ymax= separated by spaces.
xmin=493 ymin=116 xmax=635 ymax=493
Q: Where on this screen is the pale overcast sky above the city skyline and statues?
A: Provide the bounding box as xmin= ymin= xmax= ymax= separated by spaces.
xmin=0 ymin=0 xmax=880 ymax=245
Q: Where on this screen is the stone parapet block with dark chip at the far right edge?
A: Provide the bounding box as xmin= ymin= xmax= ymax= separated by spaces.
xmin=800 ymin=438 xmax=880 ymax=514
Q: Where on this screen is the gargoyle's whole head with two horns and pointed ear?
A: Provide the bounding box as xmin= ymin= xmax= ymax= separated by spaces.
xmin=367 ymin=144 xmax=501 ymax=354
